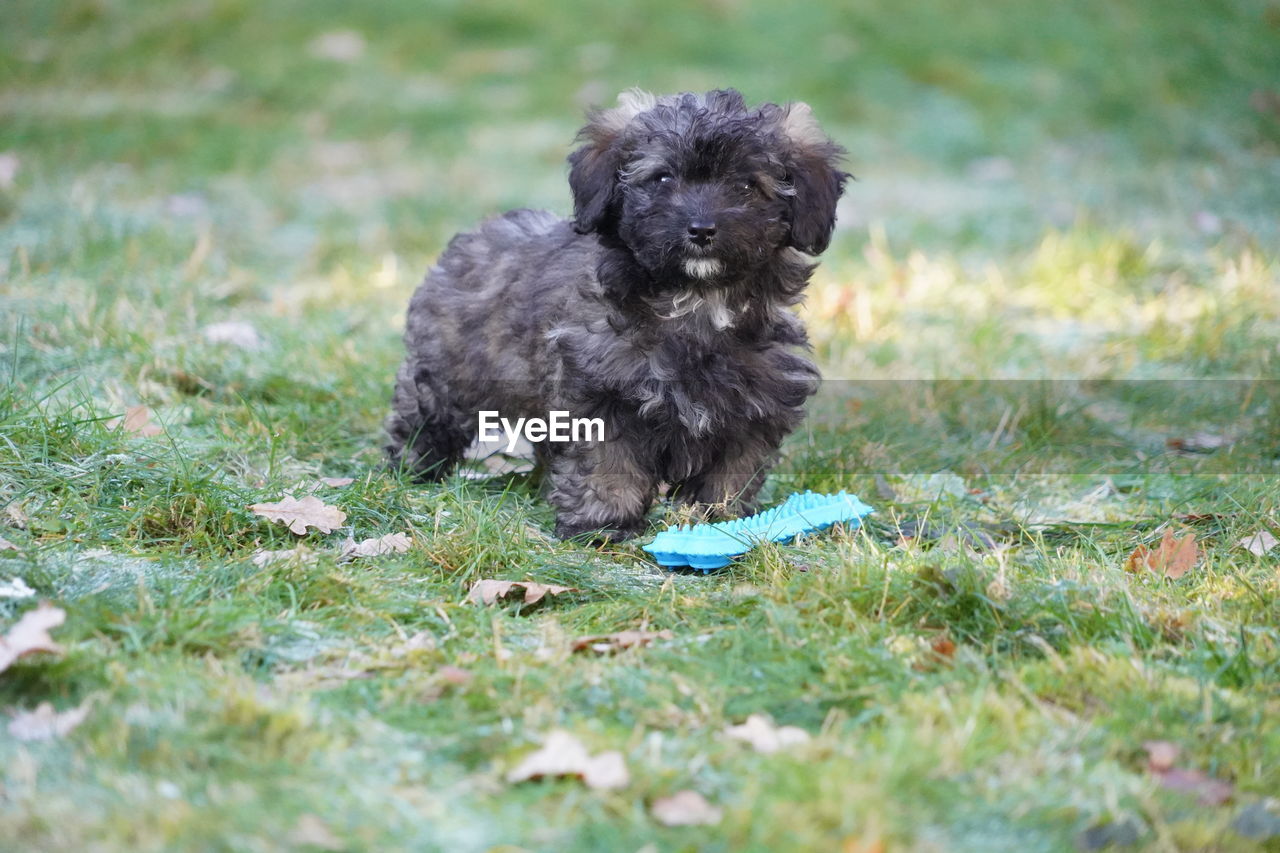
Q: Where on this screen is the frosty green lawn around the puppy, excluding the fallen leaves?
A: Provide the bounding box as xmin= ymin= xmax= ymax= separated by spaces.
xmin=0 ymin=0 xmax=1280 ymax=850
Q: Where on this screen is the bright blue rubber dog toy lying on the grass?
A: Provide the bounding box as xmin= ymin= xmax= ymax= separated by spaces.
xmin=643 ymin=492 xmax=872 ymax=574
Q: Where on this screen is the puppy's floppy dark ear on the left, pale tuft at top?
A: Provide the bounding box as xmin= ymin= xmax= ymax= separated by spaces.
xmin=568 ymin=88 xmax=657 ymax=234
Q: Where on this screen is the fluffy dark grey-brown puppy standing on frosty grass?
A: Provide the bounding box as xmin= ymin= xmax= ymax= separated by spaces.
xmin=387 ymin=90 xmax=849 ymax=539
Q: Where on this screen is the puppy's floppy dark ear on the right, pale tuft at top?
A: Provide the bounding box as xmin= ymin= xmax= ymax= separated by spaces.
xmin=777 ymin=102 xmax=850 ymax=255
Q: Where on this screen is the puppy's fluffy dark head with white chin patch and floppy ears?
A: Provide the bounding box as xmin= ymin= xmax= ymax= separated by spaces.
xmin=568 ymin=90 xmax=849 ymax=283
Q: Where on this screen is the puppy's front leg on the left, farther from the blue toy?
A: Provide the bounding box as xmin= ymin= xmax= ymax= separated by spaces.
xmin=547 ymin=439 xmax=658 ymax=542
